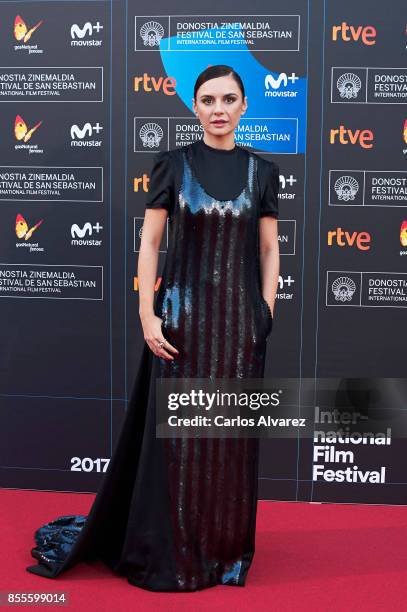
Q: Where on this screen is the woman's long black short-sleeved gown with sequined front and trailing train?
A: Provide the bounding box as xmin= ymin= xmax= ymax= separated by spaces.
xmin=26 ymin=141 xmax=279 ymax=591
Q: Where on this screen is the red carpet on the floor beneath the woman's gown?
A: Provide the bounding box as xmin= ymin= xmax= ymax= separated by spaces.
xmin=0 ymin=489 xmax=407 ymax=612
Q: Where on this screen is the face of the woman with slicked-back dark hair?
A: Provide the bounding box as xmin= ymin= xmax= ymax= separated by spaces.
xmin=193 ymin=75 xmax=247 ymax=136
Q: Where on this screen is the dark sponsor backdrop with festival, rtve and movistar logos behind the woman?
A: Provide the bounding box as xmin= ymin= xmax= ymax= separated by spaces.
xmin=0 ymin=0 xmax=407 ymax=504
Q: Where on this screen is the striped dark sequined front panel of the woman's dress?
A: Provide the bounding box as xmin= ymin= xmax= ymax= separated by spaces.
xmin=156 ymin=146 xmax=271 ymax=589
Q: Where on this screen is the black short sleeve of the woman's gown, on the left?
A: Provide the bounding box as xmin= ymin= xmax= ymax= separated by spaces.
xmin=145 ymin=151 xmax=174 ymax=215
